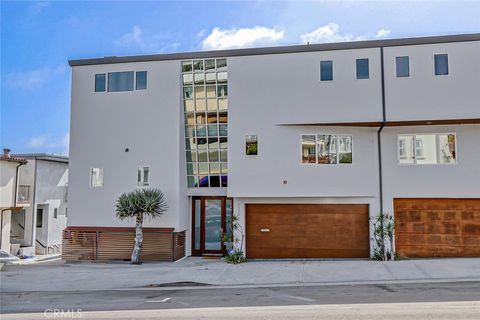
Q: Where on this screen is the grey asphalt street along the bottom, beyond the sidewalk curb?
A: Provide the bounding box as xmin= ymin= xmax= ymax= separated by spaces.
xmin=1 ymin=282 xmax=480 ymax=319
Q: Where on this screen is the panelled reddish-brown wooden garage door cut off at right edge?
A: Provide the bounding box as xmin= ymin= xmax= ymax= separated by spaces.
xmin=394 ymin=199 xmax=480 ymax=257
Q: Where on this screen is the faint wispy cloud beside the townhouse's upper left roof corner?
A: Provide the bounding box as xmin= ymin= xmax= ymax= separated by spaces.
xmin=5 ymin=64 xmax=68 ymax=89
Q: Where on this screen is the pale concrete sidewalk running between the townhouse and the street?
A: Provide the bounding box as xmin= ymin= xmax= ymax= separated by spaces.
xmin=0 ymin=257 xmax=480 ymax=292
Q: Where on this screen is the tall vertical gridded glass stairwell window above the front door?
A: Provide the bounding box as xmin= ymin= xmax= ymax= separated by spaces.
xmin=181 ymin=59 xmax=228 ymax=188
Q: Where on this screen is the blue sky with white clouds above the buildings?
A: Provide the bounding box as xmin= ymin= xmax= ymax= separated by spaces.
xmin=0 ymin=0 xmax=480 ymax=155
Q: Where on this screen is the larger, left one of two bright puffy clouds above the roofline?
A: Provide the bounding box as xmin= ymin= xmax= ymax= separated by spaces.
xmin=202 ymin=26 xmax=285 ymax=50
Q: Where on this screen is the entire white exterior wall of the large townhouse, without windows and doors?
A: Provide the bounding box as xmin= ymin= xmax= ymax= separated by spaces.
xmin=68 ymin=37 xmax=480 ymax=254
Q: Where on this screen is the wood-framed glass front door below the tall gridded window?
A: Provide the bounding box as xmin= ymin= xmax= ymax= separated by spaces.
xmin=192 ymin=197 xmax=232 ymax=256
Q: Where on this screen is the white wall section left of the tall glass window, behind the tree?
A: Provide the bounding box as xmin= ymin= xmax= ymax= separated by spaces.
xmin=68 ymin=61 xmax=188 ymax=231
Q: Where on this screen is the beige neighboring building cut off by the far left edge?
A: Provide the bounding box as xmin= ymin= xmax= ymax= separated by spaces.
xmin=0 ymin=149 xmax=27 ymax=253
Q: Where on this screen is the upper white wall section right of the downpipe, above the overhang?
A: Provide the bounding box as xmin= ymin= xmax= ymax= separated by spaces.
xmin=384 ymin=41 xmax=480 ymax=121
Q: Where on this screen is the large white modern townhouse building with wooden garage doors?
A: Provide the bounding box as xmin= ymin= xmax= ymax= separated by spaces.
xmin=64 ymin=34 xmax=480 ymax=260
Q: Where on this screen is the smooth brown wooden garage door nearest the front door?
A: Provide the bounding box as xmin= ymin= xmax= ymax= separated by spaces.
xmin=246 ymin=204 xmax=370 ymax=258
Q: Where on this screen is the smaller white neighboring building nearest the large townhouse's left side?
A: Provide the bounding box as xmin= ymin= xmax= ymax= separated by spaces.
xmin=11 ymin=153 xmax=68 ymax=255
